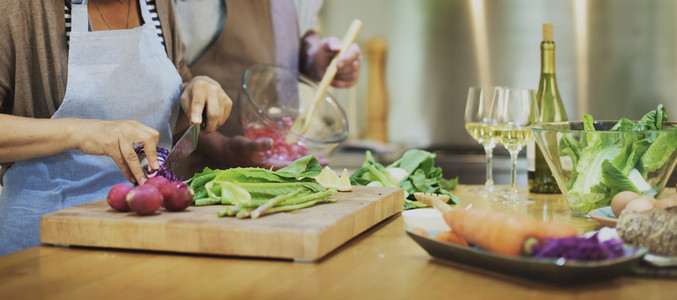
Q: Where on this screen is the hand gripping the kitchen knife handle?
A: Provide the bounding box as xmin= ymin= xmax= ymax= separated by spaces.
xmin=180 ymin=76 xmax=233 ymax=133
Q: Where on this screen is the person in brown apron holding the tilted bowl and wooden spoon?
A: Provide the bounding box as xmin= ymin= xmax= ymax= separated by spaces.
xmin=176 ymin=0 xmax=361 ymax=174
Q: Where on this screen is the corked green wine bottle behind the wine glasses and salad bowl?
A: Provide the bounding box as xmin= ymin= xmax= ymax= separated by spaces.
xmin=527 ymin=23 xmax=568 ymax=194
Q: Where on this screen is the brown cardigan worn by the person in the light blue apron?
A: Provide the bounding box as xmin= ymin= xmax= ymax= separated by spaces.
xmin=0 ymin=0 xmax=191 ymax=178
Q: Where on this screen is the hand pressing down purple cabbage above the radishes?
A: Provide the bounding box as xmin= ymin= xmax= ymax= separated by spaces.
xmin=77 ymin=120 xmax=160 ymax=184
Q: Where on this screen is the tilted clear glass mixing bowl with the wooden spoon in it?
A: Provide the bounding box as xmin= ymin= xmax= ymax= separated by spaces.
xmin=239 ymin=64 xmax=348 ymax=164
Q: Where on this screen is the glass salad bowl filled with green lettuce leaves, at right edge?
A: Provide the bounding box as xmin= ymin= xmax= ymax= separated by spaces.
xmin=531 ymin=121 xmax=677 ymax=216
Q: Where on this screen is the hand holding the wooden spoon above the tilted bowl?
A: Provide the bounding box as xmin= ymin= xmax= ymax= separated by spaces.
xmin=304 ymin=37 xmax=362 ymax=88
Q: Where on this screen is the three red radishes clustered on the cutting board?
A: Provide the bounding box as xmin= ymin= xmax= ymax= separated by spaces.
xmin=106 ymin=176 xmax=195 ymax=215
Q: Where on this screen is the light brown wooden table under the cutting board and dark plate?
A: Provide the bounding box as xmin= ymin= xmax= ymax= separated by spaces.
xmin=0 ymin=186 xmax=677 ymax=299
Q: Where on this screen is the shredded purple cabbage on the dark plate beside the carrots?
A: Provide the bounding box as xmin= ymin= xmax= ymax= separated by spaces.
xmin=532 ymin=232 xmax=625 ymax=261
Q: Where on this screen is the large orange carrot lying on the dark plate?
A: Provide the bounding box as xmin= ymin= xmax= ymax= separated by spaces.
xmin=444 ymin=208 xmax=576 ymax=256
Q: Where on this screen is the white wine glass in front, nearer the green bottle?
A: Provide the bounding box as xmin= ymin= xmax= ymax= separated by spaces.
xmin=491 ymin=88 xmax=538 ymax=203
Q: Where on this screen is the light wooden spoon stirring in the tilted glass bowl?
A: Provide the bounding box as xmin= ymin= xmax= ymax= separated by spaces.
xmin=291 ymin=19 xmax=362 ymax=139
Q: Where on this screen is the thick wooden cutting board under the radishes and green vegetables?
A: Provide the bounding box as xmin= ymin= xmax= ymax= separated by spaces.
xmin=40 ymin=186 xmax=404 ymax=261
